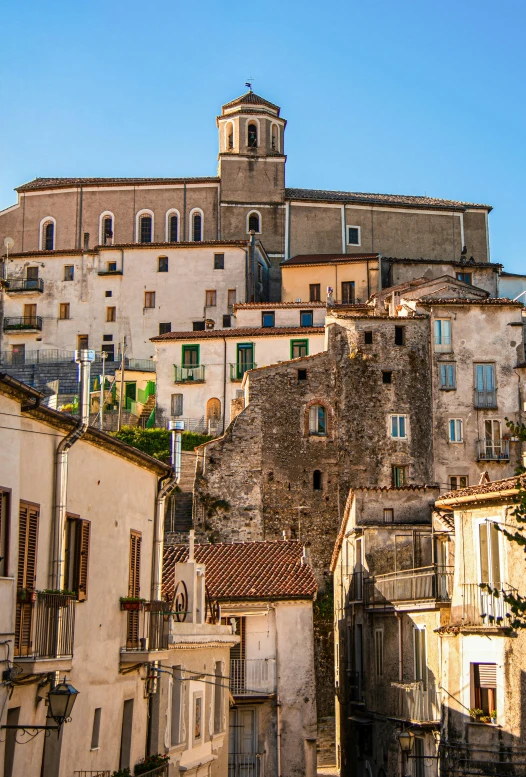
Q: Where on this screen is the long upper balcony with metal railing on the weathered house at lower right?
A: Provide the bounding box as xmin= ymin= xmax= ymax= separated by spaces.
xmin=364 ymin=565 xmax=453 ymax=610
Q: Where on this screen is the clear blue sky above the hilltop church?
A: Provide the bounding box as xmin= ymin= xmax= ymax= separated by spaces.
xmin=0 ymin=0 xmax=526 ymax=273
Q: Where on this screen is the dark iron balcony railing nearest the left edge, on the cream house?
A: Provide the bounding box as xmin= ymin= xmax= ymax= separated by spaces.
xmin=15 ymin=593 xmax=75 ymax=659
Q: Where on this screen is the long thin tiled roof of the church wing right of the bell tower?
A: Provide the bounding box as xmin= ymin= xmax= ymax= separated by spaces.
xmin=285 ymin=189 xmax=492 ymax=211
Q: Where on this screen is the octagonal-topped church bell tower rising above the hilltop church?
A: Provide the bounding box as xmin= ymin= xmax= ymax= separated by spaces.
xmin=217 ymin=90 xmax=287 ymax=299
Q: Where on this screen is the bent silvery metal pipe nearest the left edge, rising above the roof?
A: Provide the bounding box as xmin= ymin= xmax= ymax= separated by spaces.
xmin=51 ymin=349 xmax=95 ymax=591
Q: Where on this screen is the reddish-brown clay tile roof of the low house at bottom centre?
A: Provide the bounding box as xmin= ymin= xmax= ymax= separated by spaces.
xmin=163 ymin=540 xmax=318 ymax=600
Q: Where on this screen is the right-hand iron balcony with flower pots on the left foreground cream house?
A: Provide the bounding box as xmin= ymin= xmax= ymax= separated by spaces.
xmin=121 ymin=601 xmax=170 ymax=664
